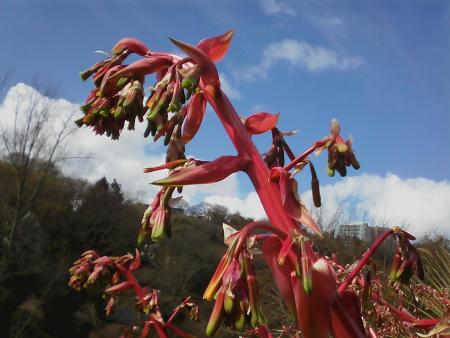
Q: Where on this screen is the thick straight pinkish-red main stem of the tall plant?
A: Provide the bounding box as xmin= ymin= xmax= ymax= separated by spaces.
xmin=206 ymin=90 xmax=298 ymax=233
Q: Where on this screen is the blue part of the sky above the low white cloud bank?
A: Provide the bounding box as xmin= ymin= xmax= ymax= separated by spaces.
xmin=0 ymin=0 xmax=450 ymax=236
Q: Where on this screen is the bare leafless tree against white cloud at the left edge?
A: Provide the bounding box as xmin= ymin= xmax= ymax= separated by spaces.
xmin=0 ymin=82 xmax=76 ymax=276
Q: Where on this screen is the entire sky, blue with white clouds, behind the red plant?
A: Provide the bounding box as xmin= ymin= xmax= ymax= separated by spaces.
xmin=0 ymin=0 xmax=450 ymax=238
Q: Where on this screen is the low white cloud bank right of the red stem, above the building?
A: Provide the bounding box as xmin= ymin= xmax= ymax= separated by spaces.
xmin=302 ymin=174 xmax=450 ymax=236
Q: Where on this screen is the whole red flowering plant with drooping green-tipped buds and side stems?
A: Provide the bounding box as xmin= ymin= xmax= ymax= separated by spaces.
xmin=69 ymin=30 xmax=437 ymax=338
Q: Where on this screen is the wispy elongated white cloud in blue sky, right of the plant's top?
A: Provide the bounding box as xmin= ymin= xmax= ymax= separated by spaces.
xmin=236 ymin=39 xmax=364 ymax=80
